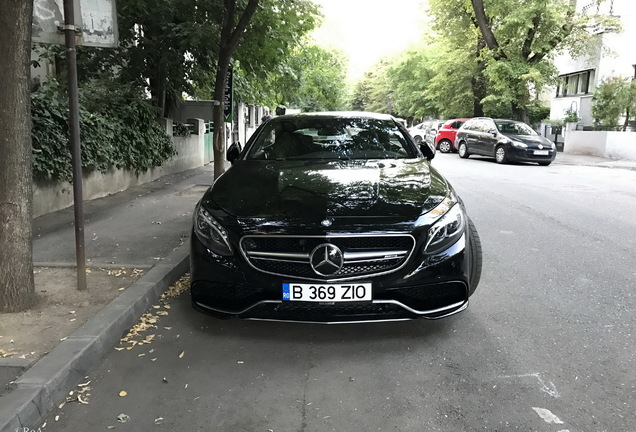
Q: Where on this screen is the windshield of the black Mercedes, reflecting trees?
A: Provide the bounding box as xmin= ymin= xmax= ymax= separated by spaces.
xmin=246 ymin=117 xmax=416 ymax=160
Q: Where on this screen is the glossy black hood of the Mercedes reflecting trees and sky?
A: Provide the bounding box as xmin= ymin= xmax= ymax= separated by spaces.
xmin=203 ymin=159 xmax=449 ymax=220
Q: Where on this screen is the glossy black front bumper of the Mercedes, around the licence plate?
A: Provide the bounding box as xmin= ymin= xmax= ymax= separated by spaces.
xmin=190 ymin=233 xmax=470 ymax=323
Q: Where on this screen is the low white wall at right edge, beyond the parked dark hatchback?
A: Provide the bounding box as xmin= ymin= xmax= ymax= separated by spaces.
xmin=564 ymin=130 xmax=636 ymax=161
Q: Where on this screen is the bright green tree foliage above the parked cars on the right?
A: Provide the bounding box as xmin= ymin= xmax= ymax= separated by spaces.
xmin=352 ymin=0 xmax=617 ymax=122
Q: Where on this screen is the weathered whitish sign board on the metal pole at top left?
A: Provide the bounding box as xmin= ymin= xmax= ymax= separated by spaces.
xmin=31 ymin=0 xmax=119 ymax=48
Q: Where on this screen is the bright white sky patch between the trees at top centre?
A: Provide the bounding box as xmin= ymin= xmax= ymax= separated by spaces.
xmin=314 ymin=0 xmax=426 ymax=80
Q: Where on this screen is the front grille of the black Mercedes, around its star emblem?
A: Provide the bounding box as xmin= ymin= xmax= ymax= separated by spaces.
xmin=241 ymin=234 xmax=415 ymax=281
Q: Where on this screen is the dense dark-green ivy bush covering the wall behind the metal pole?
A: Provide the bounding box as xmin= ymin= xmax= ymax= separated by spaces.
xmin=31 ymin=80 xmax=175 ymax=181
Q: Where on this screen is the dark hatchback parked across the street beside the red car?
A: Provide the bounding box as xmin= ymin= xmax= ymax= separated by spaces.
xmin=455 ymin=117 xmax=557 ymax=166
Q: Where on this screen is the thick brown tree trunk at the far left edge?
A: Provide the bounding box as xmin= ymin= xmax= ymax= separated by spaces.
xmin=0 ymin=0 xmax=35 ymax=312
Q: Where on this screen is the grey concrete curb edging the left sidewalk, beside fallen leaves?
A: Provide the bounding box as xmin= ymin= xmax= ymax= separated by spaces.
xmin=0 ymin=246 xmax=189 ymax=432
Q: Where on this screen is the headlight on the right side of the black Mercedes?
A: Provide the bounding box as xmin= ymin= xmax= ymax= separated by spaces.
xmin=423 ymin=197 xmax=466 ymax=254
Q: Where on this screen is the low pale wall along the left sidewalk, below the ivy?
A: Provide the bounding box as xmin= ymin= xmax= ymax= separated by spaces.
xmin=33 ymin=119 xmax=205 ymax=218
